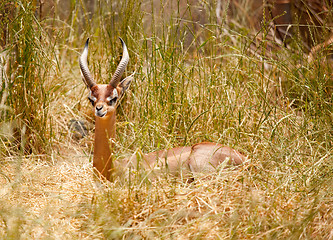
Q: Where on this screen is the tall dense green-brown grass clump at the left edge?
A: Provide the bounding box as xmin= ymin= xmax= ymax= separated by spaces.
xmin=0 ymin=1 xmax=55 ymax=155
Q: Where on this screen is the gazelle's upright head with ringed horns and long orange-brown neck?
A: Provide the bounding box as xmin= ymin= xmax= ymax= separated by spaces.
xmin=79 ymin=38 xmax=133 ymax=180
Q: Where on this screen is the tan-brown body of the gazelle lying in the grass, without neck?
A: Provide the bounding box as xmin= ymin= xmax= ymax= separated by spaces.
xmin=129 ymin=142 xmax=246 ymax=178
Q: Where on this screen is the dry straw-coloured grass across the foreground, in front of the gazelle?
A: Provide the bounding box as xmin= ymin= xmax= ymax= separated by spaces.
xmin=0 ymin=150 xmax=333 ymax=239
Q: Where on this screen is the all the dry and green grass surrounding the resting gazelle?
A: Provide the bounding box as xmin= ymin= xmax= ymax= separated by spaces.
xmin=0 ymin=0 xmax=333 ymax=239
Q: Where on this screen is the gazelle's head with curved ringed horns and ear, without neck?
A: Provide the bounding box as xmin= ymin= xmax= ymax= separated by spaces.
xmin=79 ymin=38 xmax=133 ymax=118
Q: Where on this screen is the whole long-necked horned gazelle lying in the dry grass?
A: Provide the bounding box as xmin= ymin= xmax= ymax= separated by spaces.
xmin=79 ymin=38 xmax=245 ymax=180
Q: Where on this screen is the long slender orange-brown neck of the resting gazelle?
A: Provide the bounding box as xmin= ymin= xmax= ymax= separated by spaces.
xmin=93 ymin=112 xmax=116 ymax=180
